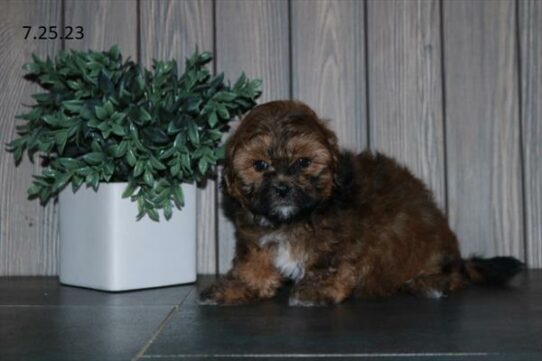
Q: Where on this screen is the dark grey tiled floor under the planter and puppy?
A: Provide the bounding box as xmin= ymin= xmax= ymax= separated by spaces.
xmin=0 ymin=271 xmax=542 ymax=361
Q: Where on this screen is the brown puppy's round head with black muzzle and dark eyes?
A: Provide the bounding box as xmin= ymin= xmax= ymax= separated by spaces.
xmin=225 ymin=101 xmax=338 ymax=222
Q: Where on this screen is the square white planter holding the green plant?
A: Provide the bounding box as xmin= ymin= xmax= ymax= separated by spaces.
xmin=59 ymin=183 xmax=196 ymax=291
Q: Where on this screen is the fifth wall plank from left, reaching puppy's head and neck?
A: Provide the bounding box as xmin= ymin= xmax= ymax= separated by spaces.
xmin=291 ymin=0 xmax=367 ymax=150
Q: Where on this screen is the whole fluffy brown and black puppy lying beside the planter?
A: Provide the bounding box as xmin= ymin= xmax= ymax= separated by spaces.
xmin=201 ymin=101 xmax=522 ymax=306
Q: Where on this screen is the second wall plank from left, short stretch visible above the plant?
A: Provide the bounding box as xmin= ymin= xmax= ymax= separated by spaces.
xmin=64 ymin=0 xmax=137 ymax=56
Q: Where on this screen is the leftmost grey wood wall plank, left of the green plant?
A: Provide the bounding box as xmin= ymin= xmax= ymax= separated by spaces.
xmin=0 ymin=0 xmax=61 ymax=276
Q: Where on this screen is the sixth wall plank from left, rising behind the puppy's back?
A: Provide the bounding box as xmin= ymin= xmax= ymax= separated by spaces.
xmin=367 ymin=0 xmax=446 ymax=209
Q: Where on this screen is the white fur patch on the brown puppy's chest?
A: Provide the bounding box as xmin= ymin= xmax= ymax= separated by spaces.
xmin=260 ymin=232 xmax=305 ymax=282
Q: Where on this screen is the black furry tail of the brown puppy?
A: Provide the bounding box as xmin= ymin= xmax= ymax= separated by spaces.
xmin=463 ymin=257 xmax=525 ymax=286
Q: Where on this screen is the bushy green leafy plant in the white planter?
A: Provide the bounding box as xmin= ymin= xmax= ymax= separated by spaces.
xmin=8 ymin=47 xmax=261 ymax=220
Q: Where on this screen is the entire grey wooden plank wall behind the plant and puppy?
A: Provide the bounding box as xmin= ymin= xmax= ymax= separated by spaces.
xmin=0 ymin=0 xmax=542 ymax=275
